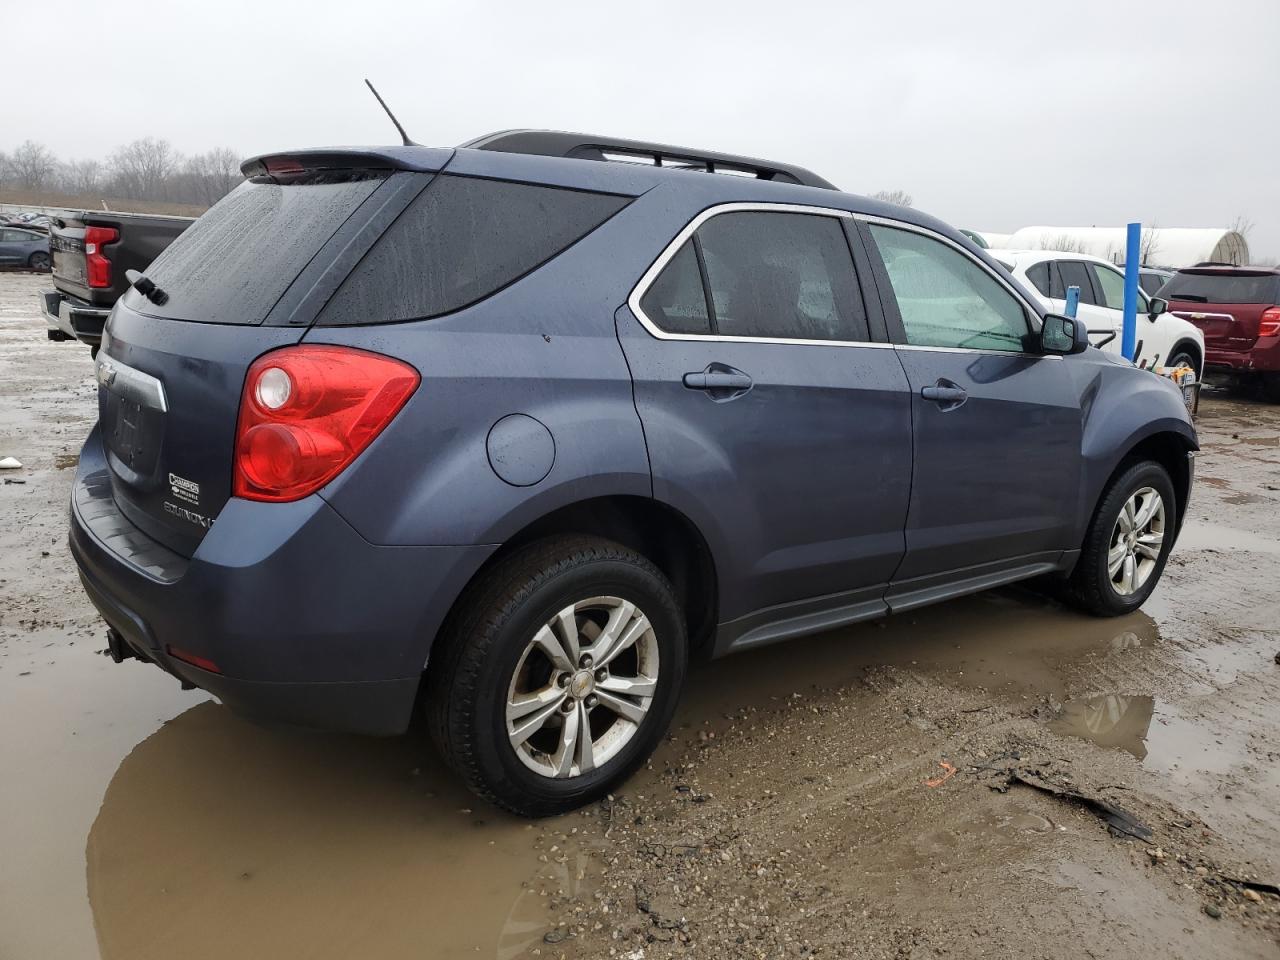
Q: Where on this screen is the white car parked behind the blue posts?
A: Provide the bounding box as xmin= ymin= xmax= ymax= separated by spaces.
xmin=988 ymin=250 xmax=1204 ymax=376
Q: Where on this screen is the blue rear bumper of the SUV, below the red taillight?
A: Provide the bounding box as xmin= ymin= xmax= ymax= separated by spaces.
xmin=70 ymin=428 xmax=493 ymax=735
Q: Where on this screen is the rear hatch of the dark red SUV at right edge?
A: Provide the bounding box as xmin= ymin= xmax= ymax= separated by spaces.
xmin=1160 ymin=268 xmax=1280 ymax=351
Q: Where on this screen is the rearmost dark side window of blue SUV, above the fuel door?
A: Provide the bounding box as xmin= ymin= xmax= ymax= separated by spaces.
xmin=316 ymin=175 xmax=630 ymax=325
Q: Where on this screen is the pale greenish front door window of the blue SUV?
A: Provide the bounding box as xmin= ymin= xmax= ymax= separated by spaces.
xmin=870 ymin=224 xmax=1030 ymax=352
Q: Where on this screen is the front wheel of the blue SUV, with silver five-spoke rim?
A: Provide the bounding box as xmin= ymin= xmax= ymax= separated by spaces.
xmin=1068 ymin=460 xmax=1178 ymax=617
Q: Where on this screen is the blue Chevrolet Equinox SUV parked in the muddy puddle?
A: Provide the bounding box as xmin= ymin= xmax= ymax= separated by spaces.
xmin=70 ymin=131 xmax=1197 ymax=815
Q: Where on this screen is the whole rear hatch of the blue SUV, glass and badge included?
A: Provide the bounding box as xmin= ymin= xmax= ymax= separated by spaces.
xmin=98 ymin=164 xmax=430 ymax=557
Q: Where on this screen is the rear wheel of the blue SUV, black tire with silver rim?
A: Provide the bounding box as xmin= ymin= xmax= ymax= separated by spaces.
xmin=425 ymin=536 xmax=687 ymax=817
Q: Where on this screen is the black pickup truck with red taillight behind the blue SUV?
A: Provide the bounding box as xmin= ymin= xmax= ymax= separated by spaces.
xmin=40 ymin=210 xmax=195 ymax=353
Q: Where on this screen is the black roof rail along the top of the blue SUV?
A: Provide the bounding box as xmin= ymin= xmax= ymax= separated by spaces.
xmin=460 ymin=131 xmax=836 ymax=189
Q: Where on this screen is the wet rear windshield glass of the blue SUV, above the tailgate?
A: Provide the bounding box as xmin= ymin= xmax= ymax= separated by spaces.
xmin=142 ymin=173 xmax=383 ymax=324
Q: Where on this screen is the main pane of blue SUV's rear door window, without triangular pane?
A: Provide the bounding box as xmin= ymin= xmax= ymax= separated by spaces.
xmin=698 ymin=212 xmax=870 ymax=340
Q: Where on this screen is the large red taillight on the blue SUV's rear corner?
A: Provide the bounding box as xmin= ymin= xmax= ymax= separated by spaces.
xmin=232 ymin=344 xmax=421 ymax=502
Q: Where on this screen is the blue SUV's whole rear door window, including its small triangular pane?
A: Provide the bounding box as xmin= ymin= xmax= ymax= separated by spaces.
xmin=640 ymin=211 xmax=869 ymax=342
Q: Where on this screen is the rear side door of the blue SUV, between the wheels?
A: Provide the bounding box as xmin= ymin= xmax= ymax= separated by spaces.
xmin=616 ymin=211 xmax=911 ymax=632
